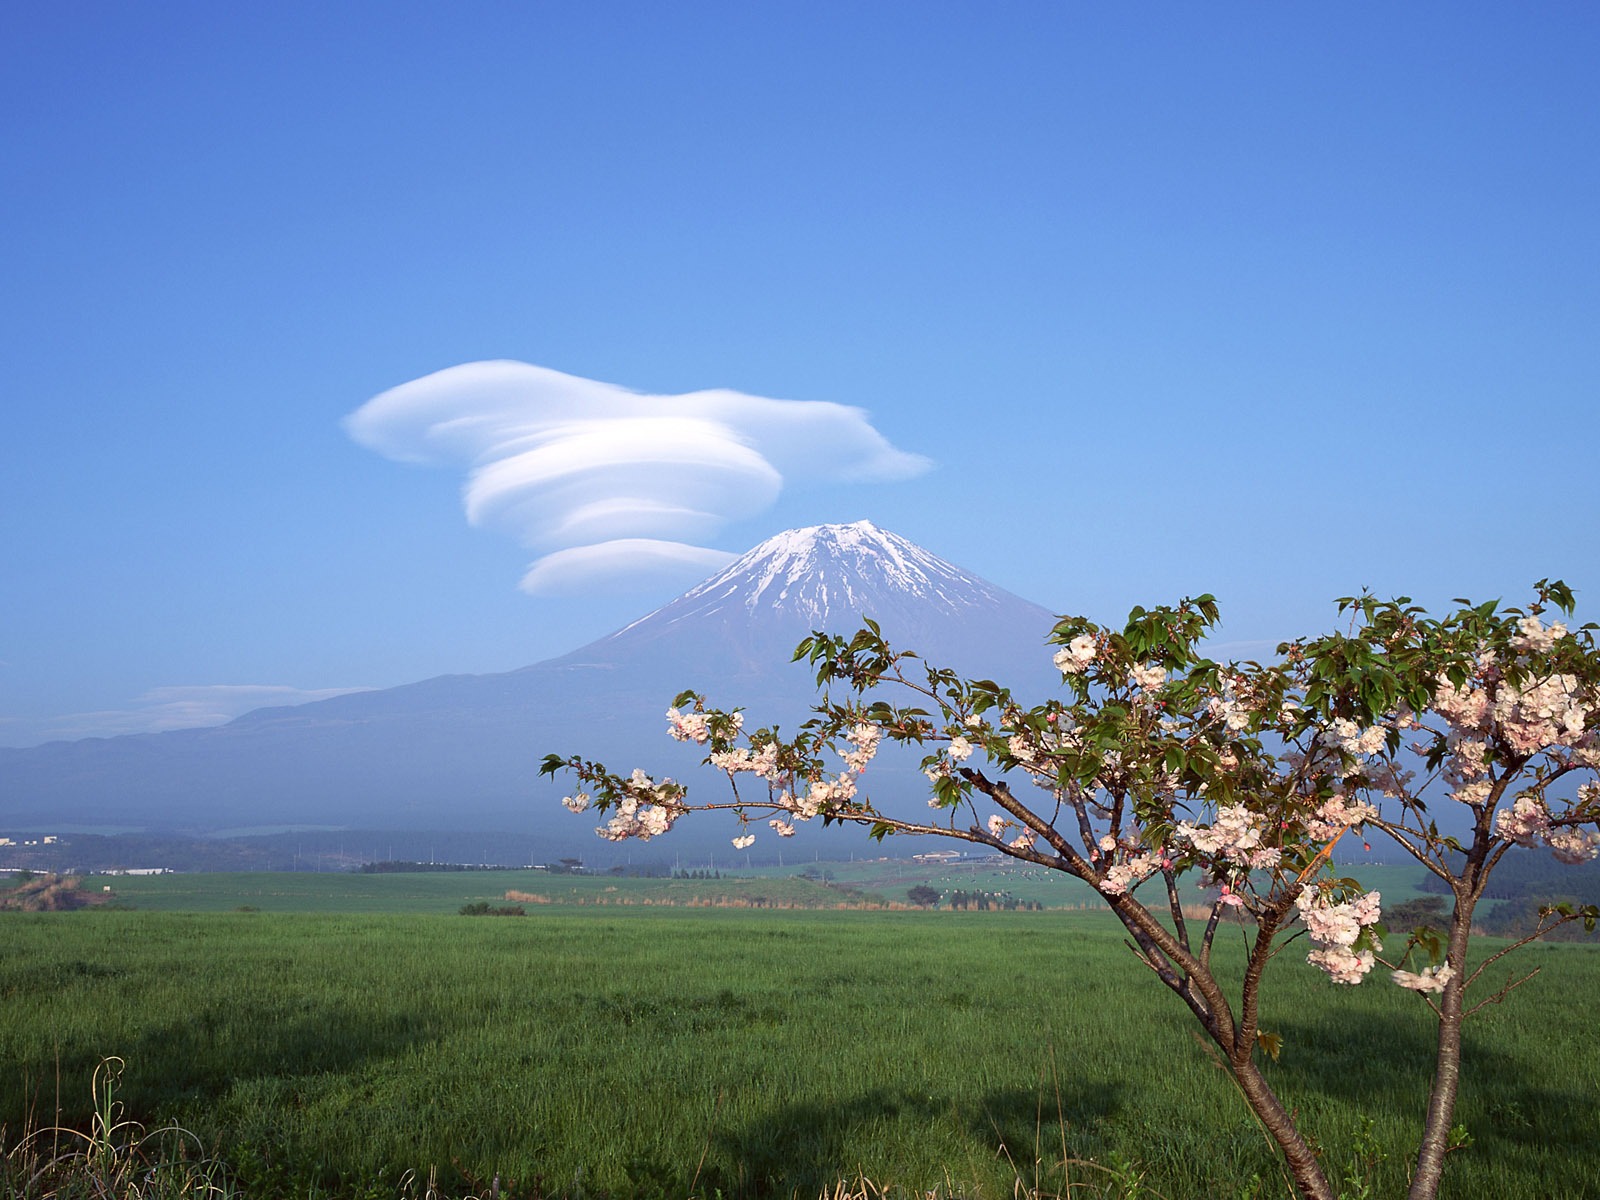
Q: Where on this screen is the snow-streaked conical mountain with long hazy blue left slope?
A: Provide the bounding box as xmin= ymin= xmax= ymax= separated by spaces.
xmin=0 ymin=522 xmax=1059 ymax=854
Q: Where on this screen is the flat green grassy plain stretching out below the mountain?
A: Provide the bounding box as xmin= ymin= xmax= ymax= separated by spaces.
xmin=0 ymin=859 xmax=1600 ymax=1200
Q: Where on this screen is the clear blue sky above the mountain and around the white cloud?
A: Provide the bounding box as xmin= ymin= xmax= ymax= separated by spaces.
xmin=0 ymin=3 xmax=1600 ymax=746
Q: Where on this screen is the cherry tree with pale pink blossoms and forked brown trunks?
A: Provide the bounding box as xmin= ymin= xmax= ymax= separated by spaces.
xmin=541 ymin=581 xmax=1600 ymax=1200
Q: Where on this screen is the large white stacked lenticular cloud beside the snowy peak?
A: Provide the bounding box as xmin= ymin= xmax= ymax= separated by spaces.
xmin=344 ymin=362 xmax=930 ymax=594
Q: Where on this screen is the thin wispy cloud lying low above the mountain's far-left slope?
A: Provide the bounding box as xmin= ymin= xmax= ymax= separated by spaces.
xmin=0 ymin=683 xmax=368 ymax=746
